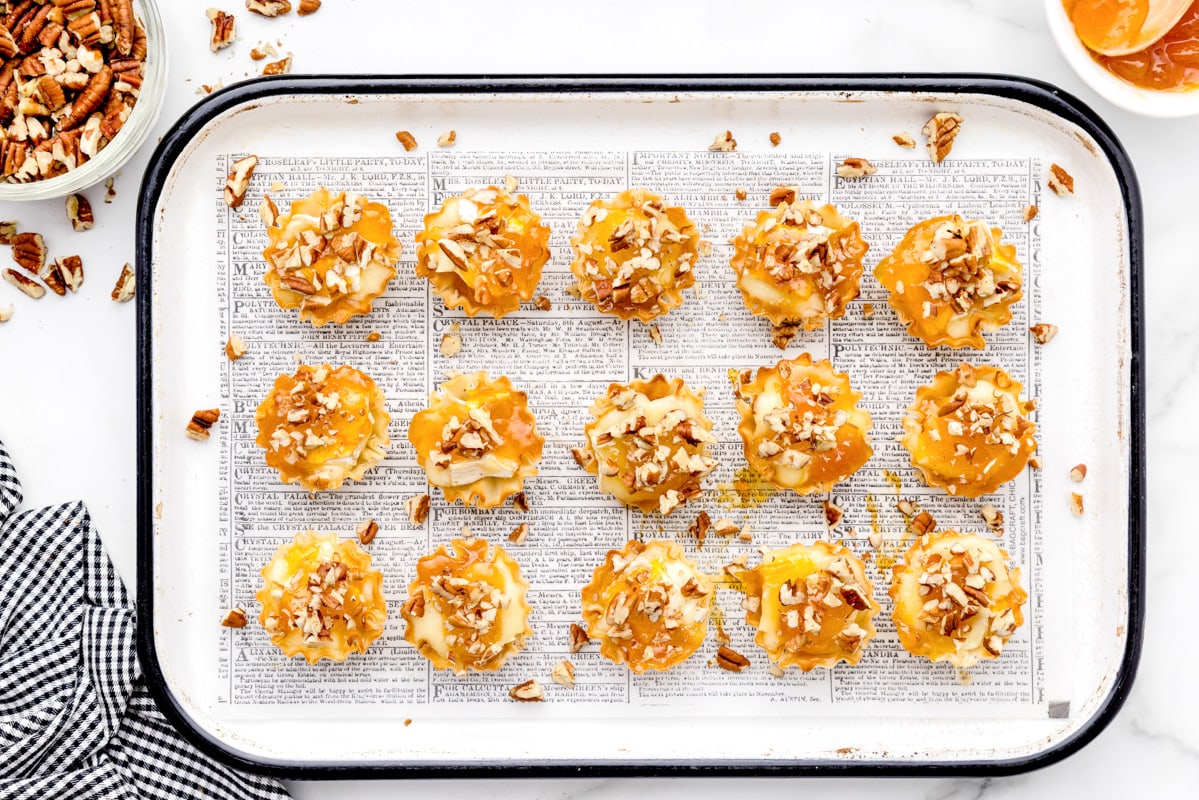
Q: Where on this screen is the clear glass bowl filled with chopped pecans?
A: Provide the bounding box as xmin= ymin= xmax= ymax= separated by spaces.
xmin=0 ymin=0 xmax=167 ymax=200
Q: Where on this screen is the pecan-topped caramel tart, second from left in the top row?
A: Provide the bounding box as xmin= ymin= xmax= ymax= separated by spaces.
xmin=416 ymin=186 xmax=549 ymax=319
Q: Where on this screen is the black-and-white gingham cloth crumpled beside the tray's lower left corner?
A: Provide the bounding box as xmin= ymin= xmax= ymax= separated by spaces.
xmin=0 ymin=443 xmax=289 ymax=800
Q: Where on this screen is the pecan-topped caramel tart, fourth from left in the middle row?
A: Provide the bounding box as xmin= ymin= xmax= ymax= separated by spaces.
xmin=734 ymin=353 xmax=874 ymax=494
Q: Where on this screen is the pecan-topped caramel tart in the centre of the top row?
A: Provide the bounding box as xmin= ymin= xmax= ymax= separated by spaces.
xmin=571 ymin=188 xmax=699 ymax=323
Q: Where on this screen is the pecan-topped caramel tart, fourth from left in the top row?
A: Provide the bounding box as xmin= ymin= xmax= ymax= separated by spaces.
xmin=729 ymin=191 xmax=869 ymax=348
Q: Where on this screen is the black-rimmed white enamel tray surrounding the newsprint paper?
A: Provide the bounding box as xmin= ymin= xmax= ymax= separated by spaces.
xmin=138 ymin=76 xmax=1145 ymax=777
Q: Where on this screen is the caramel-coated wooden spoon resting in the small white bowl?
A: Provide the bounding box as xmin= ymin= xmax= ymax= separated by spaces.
xmin=1066 ymin=0 xmax=1194 ymax=55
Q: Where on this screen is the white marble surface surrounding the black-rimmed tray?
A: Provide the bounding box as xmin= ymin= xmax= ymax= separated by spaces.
xmin=0 ymin=0 xmax=1199 ymax=800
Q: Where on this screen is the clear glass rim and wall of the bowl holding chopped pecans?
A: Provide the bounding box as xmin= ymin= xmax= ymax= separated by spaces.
xmin=0 ymin=0 xmax=167 ymax=200
